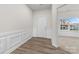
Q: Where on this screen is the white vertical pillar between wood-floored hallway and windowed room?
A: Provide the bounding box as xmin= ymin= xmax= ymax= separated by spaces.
xmin=51 ymin=4 xmax=64 ymax=48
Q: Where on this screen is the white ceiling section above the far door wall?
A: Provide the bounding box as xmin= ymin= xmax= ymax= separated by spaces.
xmin=28 ymin=4 xmax=51 ymax=10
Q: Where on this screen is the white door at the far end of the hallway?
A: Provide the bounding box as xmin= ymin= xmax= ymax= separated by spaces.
xmin=37 ymin=16 xmax=47 ymax=37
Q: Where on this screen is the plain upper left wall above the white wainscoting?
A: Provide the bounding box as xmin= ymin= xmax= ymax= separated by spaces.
xmin=0 ymin=4 xmax=32 ymax=32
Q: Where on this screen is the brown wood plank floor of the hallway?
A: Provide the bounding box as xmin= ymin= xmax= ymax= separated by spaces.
xmin=11 ymin=37 xmax=68 ymax=54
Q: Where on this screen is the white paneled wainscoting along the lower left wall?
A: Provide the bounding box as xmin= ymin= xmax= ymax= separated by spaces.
xmin=0 ymin=30 xmax=32 ymax=54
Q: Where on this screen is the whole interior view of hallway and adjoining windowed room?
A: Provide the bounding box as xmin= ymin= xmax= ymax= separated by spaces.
xmin=0 ymin=4 xmax=79 ymax=54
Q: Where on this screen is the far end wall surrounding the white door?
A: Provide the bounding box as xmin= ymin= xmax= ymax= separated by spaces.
xmin=33 ymin=9 xmax=52 ymax=38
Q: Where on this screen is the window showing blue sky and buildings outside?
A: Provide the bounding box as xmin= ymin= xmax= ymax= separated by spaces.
xmin=60 ymin=17 xmax=79 ymax=31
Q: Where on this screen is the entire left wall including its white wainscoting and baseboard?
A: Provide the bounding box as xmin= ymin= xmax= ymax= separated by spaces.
xmin=0 ymin=4 xmax=33 ymax=53
